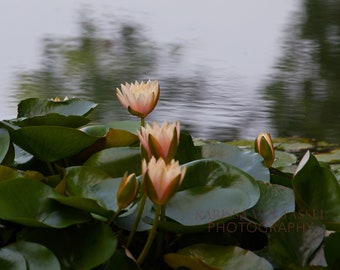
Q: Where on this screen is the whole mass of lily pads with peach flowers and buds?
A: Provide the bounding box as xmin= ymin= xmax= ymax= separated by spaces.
xmin=0 ymin=82 xmax=340 ymax=270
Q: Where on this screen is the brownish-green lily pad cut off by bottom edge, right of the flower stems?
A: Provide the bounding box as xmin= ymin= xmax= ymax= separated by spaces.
xmin=164 ymin=244 xmax=273 ymax=270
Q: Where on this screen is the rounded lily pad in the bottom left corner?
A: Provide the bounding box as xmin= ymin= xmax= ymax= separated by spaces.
xmin=0 ymin=241 xmax=61 ymax=270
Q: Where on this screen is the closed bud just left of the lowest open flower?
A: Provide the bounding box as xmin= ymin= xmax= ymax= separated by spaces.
xmin=116 ymin=173 xmax=138 ymax=209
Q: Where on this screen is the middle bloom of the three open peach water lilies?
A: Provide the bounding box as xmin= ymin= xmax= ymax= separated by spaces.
xmin=137 ymin=122 xmax=180 ymax=163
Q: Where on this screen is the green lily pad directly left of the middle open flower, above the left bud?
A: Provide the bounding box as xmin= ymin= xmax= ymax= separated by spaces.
xmin=84 ymin=147 xmax=141 ymax=177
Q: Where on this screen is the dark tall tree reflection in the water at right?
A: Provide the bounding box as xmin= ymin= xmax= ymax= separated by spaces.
xmin=265 ymin=0 xmax=340 ymax=142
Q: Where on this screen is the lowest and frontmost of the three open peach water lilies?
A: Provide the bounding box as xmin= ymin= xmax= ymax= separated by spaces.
xmin=142 ymin=157 xmax=186 ymax=205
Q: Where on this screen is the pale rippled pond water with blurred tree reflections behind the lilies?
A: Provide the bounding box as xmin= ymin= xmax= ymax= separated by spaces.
xmin=0 ymin=0 xmax=340 ymax=142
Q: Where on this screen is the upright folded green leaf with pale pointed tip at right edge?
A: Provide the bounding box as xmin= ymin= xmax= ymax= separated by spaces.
xmin=293 ymin=152 xmax=340 ymax=230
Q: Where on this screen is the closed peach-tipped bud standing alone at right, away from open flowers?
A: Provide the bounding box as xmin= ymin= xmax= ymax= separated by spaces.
xmin=255 ymin=133 xmax=275 ymax=168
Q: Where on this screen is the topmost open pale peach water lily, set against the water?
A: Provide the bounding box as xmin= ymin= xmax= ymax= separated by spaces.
xmin=116 ymin=80 xmax=160 ymax=118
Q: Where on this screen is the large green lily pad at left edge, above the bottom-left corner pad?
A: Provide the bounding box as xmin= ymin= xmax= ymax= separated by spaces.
xmin=0 ymin=178 xmax=90 ymax=228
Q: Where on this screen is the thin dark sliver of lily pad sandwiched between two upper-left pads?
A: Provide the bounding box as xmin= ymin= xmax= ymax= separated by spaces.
xmin=4 ymin=113 xmax=90 ymax=128
